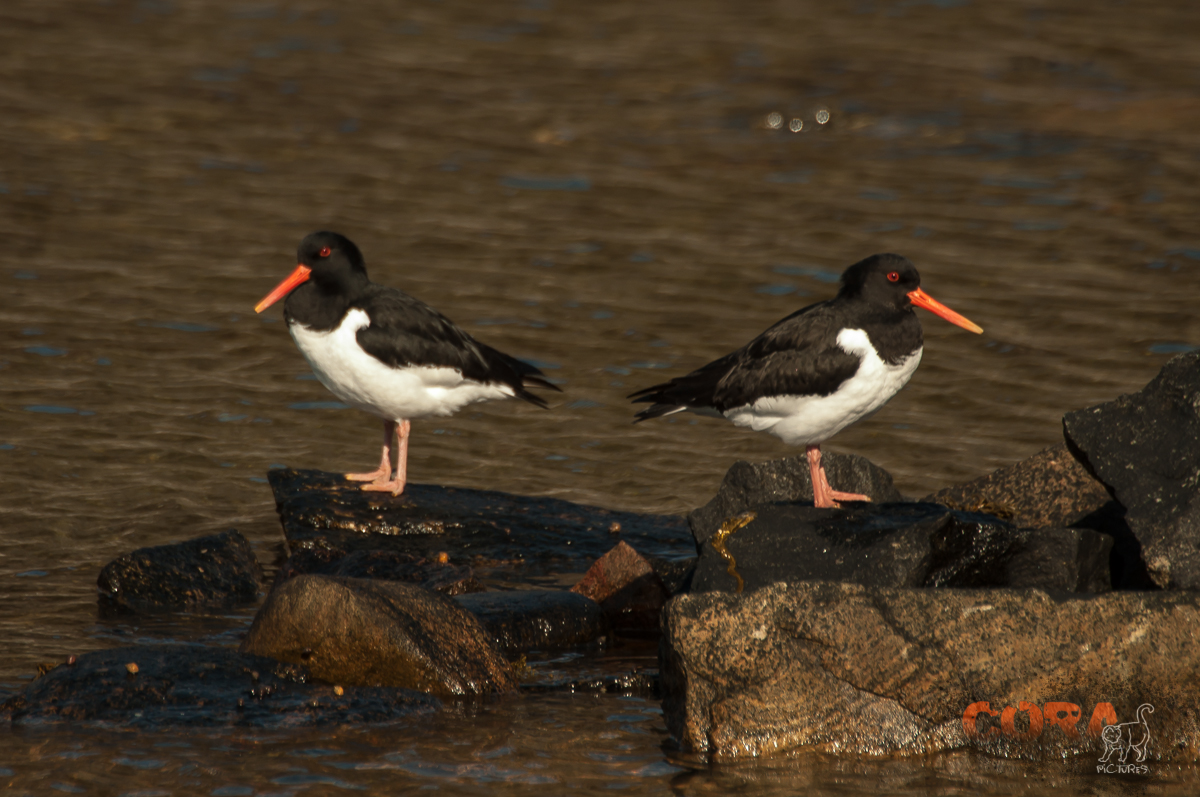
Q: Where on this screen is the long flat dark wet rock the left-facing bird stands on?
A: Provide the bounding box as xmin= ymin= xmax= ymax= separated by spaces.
xmin=268 ymin=469 xmax=694 ymax=580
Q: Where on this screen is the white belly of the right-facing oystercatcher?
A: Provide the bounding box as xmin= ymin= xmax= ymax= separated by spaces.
xmin=725 ymin=329 xmax=924 ymax=445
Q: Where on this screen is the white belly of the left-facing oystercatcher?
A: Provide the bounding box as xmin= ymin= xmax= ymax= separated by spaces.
xmin=288 ymin=310 xmax=512 ymax=420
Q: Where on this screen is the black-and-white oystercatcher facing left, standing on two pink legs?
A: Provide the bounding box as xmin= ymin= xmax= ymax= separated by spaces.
xmin=254 ymin=232 xmax=560 ymax=496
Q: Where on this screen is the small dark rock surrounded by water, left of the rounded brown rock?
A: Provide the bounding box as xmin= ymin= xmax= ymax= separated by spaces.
xmin=96 ymin=529 xmax=262 ymax=612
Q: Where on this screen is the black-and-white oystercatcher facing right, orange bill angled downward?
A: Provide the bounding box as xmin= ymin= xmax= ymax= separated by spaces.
xmin=629 ymin=253 xmax=983 ymax=508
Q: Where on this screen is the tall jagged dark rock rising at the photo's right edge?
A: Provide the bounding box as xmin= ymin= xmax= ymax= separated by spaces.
xmin=1063 ymin=352 xmax=1200 ymax=589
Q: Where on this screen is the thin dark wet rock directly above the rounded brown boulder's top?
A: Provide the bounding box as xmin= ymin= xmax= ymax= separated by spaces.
xmin=275 ymin=540 xmax=486 ymax=595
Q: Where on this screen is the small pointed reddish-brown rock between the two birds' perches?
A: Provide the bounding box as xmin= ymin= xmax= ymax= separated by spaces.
xmin=571 ymin=541 xmax=670 ymax=636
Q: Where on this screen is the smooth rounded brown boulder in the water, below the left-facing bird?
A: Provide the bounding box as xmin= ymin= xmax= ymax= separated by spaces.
xmin=241 ymin=575 xmax=516 ymax=696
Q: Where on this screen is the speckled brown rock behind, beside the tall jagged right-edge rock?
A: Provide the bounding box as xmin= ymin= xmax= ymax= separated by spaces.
xmin=922 ymin=443 xmax=1112 ymax=528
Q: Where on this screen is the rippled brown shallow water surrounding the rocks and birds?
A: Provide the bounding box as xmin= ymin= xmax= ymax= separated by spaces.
xmin=0 ymin=0 xmax=1200 ymax=793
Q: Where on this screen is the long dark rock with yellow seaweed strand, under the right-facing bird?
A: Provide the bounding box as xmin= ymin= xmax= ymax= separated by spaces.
xmin=690 ymin=503 xmax=1110 ymax=592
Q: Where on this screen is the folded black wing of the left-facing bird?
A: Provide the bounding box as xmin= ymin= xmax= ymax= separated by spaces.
xmin=353 ymin=284 xmax=559 ymax=408
